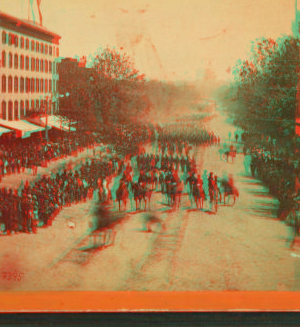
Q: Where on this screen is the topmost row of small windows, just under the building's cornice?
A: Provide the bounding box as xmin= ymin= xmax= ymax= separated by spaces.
xmin=2 ymin=31 xmax=59 ymax=57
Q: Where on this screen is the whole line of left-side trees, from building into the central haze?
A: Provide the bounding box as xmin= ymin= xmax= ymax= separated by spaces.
xmin=58 ymin=48 xmax=204 ymax=131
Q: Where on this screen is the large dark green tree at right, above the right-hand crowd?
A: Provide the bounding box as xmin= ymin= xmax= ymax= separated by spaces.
xmin=220 ymin=36 xmax=300 ymax=145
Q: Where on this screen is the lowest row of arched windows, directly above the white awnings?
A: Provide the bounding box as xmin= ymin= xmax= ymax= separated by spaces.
xmin=1 ymin=99 xmax=52 ymax=120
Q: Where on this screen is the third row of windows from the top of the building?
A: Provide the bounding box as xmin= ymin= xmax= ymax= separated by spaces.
xmin=2 ymin=75 xmax=57 ymax=93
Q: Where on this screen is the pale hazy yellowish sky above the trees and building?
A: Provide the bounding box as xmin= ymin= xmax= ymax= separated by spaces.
xmin=0 ymin=0 xmax=295 ymax=80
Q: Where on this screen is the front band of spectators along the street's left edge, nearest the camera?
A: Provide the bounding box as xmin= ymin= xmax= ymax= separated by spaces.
xmin=0 ymin=159 xmax=124 ymax=235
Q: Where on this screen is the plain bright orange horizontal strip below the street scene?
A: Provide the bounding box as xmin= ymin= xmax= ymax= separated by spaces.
xmin=0 ymin=292 xmax=300 ymax=312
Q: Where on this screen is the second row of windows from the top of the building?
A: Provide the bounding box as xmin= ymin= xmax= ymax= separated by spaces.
xmin=2 ymin=51 xmax=57 ymax=74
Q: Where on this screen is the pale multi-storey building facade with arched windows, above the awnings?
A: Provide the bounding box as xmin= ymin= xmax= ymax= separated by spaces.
xmin=0 ymin=12 xmax=61 ymax=121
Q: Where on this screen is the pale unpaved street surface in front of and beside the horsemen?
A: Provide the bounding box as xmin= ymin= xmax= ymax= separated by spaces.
xmin=0 ymin=103 xmax=300 ymax=291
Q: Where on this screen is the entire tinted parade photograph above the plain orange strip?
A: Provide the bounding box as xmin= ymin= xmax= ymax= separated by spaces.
xmin=0 ymin=0 xmax=300 ymax=312
